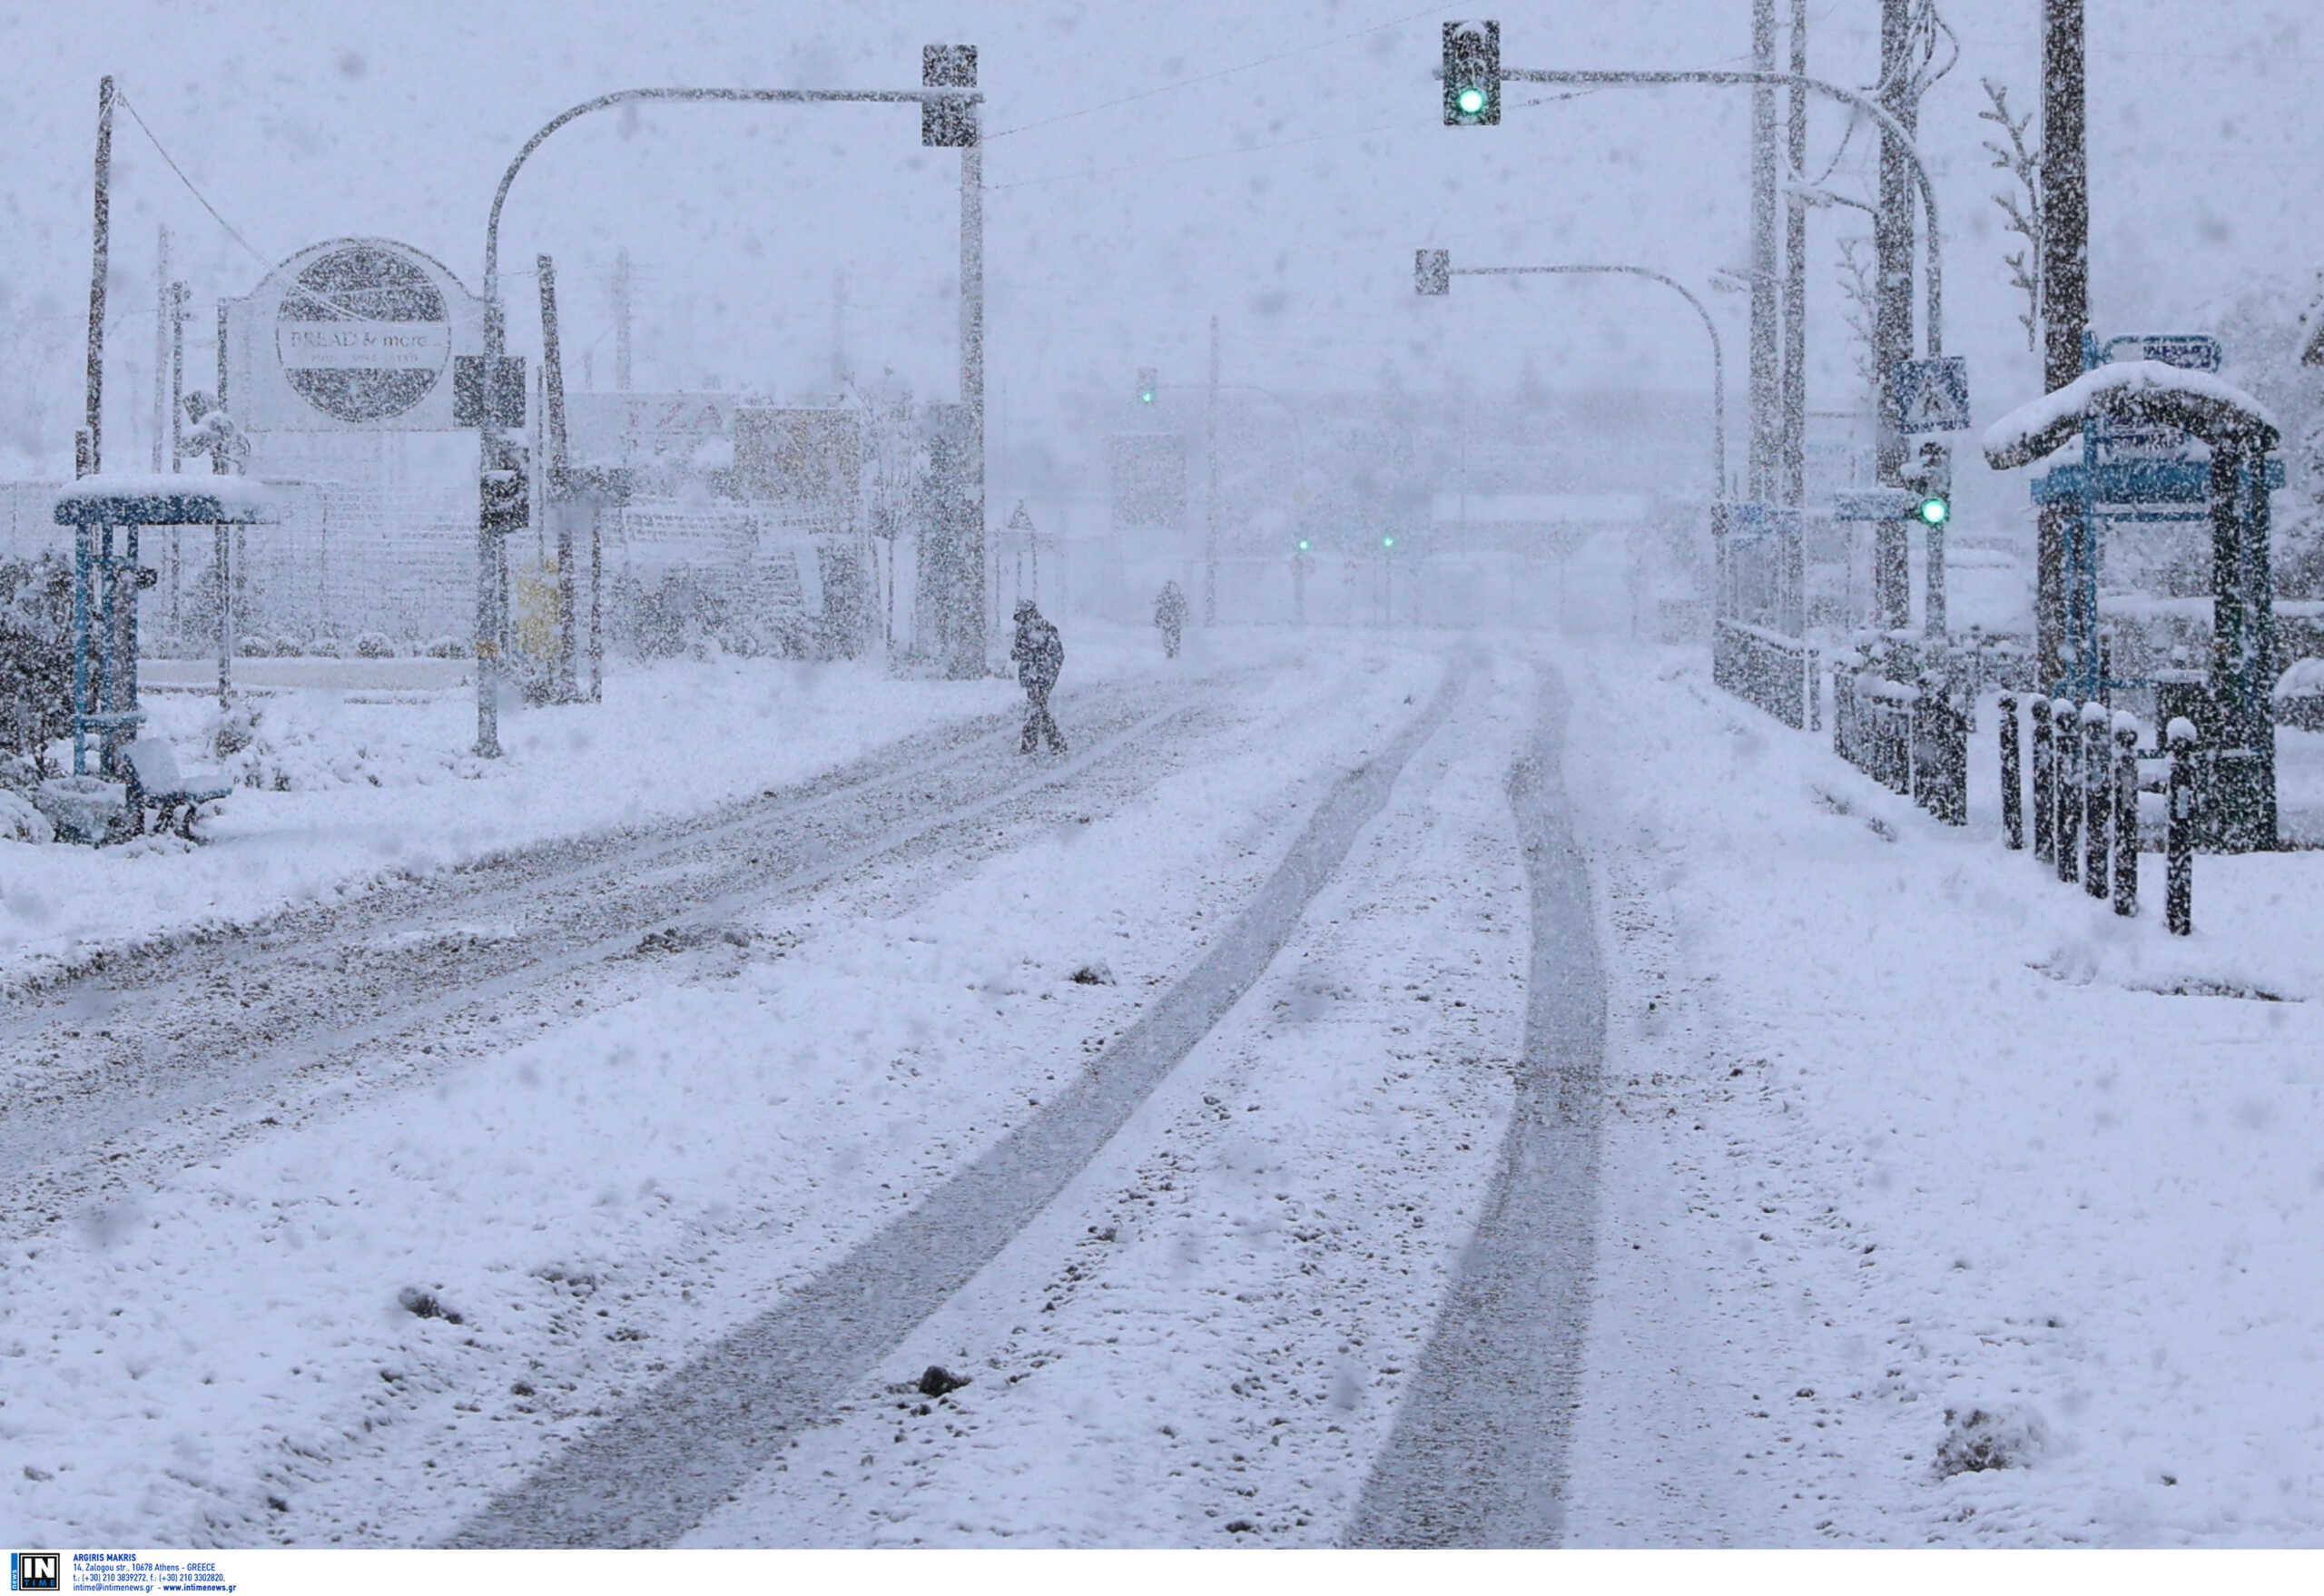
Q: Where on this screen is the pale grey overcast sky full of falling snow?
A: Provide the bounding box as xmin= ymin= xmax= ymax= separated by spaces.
xmin=0 ymin=0 xmax=2324 ymax=471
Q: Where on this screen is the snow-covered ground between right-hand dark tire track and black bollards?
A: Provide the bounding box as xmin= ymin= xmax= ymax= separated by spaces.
xmin=1569 ymin=636 xmax=2324 ymax=1545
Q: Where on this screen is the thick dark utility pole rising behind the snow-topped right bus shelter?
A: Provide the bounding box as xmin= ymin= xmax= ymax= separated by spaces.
xmin=2034 ymin=0 xmax=2089 ymax=693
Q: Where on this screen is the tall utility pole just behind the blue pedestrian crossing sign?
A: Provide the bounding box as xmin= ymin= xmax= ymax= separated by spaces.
xmin=1873 ymin=0 xmax=1920 ymax=629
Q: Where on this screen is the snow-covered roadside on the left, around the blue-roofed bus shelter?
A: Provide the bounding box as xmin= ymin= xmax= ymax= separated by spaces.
xmin=0 ymin=625 xmax=1198 ymax=980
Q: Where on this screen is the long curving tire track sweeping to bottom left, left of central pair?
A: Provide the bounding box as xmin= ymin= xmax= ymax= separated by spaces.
xmin=451 ymin=660 xmax=1471 ymax=1547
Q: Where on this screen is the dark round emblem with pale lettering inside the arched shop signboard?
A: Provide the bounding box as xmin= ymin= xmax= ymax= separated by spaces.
xmin=274 ymin=244 xmax=451 ymax=423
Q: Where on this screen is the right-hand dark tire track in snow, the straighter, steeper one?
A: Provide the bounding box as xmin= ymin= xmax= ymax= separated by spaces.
xmin=1345 ymin=666 xmax=1606 ymax=1547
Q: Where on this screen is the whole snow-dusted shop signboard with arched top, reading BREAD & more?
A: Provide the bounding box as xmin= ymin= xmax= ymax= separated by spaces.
xmin=225 ymin=240 xmax=483 ymax=432
